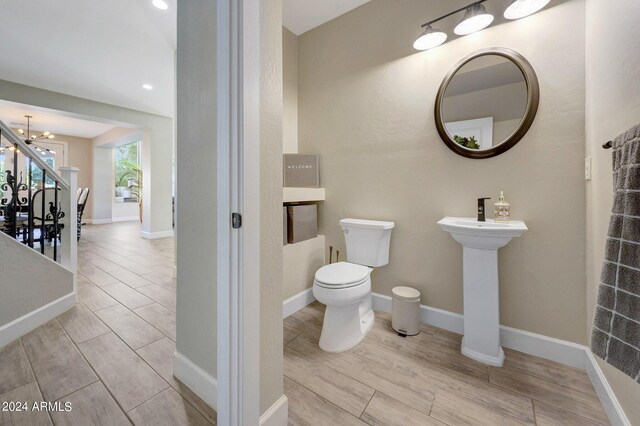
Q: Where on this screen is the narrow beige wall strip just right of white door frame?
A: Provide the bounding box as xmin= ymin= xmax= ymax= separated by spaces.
xmin=260 ymin=0 xmax=283 ymax=413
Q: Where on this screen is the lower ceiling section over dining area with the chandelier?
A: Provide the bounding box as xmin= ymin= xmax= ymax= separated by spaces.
xmin=0 ymin=101 xmax=122 ymax=138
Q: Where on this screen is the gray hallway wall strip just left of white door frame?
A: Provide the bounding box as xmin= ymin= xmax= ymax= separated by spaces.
xmin=176 ymin=0 xmax=217 ymax=377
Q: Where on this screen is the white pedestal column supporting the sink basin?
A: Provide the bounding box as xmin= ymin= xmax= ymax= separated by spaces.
xmin=462 ymin=247 xmax=504 ymax=367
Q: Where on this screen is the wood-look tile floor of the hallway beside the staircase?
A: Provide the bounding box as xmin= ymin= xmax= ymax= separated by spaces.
xmin=0 ymin=222 xmax=216 ymax=426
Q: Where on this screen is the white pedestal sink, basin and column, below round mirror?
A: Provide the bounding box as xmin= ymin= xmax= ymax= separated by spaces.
xmin=438 ymin=217 xmax=527 ymax=367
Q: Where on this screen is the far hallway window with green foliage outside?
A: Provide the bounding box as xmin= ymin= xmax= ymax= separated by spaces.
xmin=114 ymin=142 xmax=142 ymax=203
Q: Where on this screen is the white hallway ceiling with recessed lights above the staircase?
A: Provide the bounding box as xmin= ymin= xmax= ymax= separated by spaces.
xmin=0 ymin=0 xmax=176 ymax=117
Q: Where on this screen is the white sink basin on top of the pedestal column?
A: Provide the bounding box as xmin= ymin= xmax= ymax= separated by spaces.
xmin=438 ymin=217 xmax=527 ymax=250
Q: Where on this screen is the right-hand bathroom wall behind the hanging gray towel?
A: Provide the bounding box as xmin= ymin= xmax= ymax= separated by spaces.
xmin=586 ymin=0 xmax=640 ymax=425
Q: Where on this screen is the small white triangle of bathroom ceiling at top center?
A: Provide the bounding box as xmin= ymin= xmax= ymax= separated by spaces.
xmin=282 ymin=0 xmax=370 ymax=35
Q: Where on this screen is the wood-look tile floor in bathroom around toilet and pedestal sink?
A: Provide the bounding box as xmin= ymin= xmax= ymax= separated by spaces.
xmin=284 ymin=302 xmax=609 ymax=426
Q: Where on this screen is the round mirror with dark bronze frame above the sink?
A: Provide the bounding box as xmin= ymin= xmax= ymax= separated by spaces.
xmin=435 ymin=48 xmax=540 ymax=158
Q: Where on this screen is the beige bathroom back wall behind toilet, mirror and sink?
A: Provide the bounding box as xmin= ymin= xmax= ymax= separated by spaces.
xmin=298 ymin=0 xmax=587 ymax=344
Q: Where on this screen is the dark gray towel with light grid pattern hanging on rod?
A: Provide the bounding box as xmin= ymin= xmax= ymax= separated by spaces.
xmin=591 ymin=124 xmax=640 ymax=383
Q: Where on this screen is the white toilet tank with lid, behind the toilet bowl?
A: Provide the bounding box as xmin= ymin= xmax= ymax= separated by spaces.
xmin=340 ymin=219 xmax=395 ymax=267
